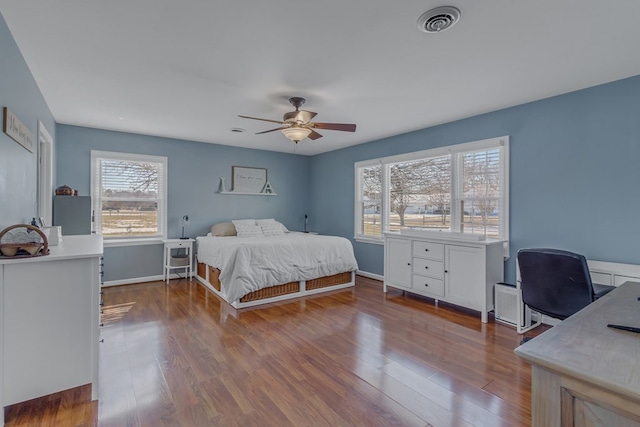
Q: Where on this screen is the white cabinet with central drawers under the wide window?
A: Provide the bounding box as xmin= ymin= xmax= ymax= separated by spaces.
xmin=384 ymin=233 xmax=504 ymax=323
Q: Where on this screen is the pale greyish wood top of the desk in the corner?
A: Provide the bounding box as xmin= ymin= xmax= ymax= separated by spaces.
xmin=515 ymin=282 xmax=640 ymax=399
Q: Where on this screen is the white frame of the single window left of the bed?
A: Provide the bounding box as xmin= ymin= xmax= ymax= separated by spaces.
xmin=91 ymin=150 xmax=169 ymax=246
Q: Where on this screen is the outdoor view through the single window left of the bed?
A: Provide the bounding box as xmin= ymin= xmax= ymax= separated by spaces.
xmin=101 ymin=159 xmax=161 ymax=237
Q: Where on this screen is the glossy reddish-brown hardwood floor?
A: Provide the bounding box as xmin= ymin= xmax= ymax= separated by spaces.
xmin=5 ymin=276 xmax=535 ymax=427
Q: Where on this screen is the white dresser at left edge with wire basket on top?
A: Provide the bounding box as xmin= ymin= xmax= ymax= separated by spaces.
xmin=0 ymin=235 xmax=102 ymax=424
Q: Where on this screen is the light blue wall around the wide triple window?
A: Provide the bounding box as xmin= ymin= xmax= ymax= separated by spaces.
xmin=310 ymin=76 xmax=640 ymax=282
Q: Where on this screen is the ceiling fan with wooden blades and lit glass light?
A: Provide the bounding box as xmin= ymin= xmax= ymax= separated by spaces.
xmin=238 ymin=96 xmax=356 ymax=144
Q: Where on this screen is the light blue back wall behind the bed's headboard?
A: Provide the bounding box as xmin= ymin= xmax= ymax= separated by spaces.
xmin=57 ymin=125 xmax=310 ymax=281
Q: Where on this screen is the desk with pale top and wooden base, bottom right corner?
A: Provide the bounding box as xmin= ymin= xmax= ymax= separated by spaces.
xmin=515 ymin=282 xmax=640 ymax=427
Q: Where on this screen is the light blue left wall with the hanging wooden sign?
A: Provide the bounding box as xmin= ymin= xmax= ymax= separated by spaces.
xmin=0 ymin=11 xmax=55 ymax=230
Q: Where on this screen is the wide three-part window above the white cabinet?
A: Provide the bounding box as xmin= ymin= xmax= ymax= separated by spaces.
xmin=355 ymin=136 xmax=509 ymax=246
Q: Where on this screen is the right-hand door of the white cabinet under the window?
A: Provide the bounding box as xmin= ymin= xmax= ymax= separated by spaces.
xmin=445 ymin=245 xmax=486 ymax=310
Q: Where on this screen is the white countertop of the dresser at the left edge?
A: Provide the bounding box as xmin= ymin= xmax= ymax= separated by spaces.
xmin=0 ymin=234 xmax=103 ymax=264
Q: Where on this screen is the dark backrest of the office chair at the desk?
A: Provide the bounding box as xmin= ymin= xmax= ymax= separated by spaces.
xmin=518 ymin=248 xmax=594 ymax=320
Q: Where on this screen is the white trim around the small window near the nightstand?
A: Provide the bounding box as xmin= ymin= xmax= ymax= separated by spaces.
xmin=91 ymin=150 xmax=169 ymax=241
